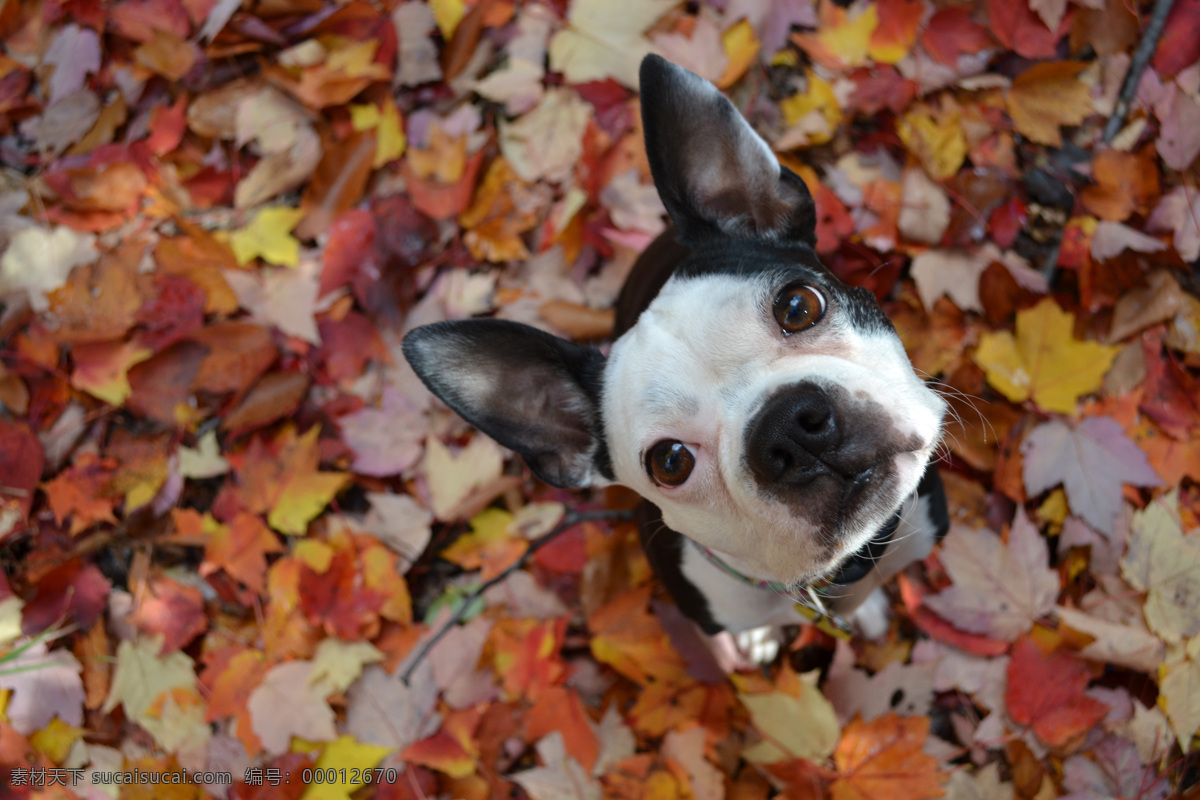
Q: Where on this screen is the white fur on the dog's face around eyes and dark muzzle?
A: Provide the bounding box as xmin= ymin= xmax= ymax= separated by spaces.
xmin=604 ymin=275 xmax=946 ymax=582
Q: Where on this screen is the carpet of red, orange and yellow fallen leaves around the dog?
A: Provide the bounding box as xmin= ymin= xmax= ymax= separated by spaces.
xmin=0 ymin=0 xmax=1200 ymax=800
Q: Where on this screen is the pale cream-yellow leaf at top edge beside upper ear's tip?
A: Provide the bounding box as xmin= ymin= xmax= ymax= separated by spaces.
xmin=550 ymin=0 xmax=676 ymax=88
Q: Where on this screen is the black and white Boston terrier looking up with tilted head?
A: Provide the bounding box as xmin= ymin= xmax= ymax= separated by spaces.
xmin=403 ymin=55 xmax=948 ymax=660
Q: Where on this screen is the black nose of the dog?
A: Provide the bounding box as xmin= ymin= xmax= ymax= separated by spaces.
xmin=746 ymin=383 xmax=841 ymax=483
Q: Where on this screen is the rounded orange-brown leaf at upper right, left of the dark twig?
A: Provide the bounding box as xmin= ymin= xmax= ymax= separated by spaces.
xmin=1008 ymin=61 xmax=1094 ymax=148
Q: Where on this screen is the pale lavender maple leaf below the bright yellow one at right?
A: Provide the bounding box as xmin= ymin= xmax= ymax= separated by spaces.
xmin=1021 ymin=416 xmax=1162 ymax=536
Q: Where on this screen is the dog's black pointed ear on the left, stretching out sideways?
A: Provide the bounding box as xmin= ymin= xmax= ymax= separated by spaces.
xmin=403 ymin=319 xmax=607 ymax=488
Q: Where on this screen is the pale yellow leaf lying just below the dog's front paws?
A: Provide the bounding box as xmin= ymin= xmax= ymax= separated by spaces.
xmin=738 ymin=672 xmax=840 ymax=764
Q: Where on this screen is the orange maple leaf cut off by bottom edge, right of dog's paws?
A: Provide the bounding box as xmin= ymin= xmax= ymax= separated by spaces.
xmin=829 ymin=714 xmax=943 ymax=800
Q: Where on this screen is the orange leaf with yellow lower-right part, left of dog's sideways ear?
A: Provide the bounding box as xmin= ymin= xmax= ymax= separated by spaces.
xmin=238 ymin=426 xmax=348 ymax=536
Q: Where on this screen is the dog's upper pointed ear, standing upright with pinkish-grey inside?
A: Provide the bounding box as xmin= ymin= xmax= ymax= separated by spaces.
xmin=641 ymin=55 xmax=816 ymax=246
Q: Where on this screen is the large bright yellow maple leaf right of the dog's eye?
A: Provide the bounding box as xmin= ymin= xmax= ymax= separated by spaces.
xmin=974 ymin=297 xmax=1120 ymax=414
